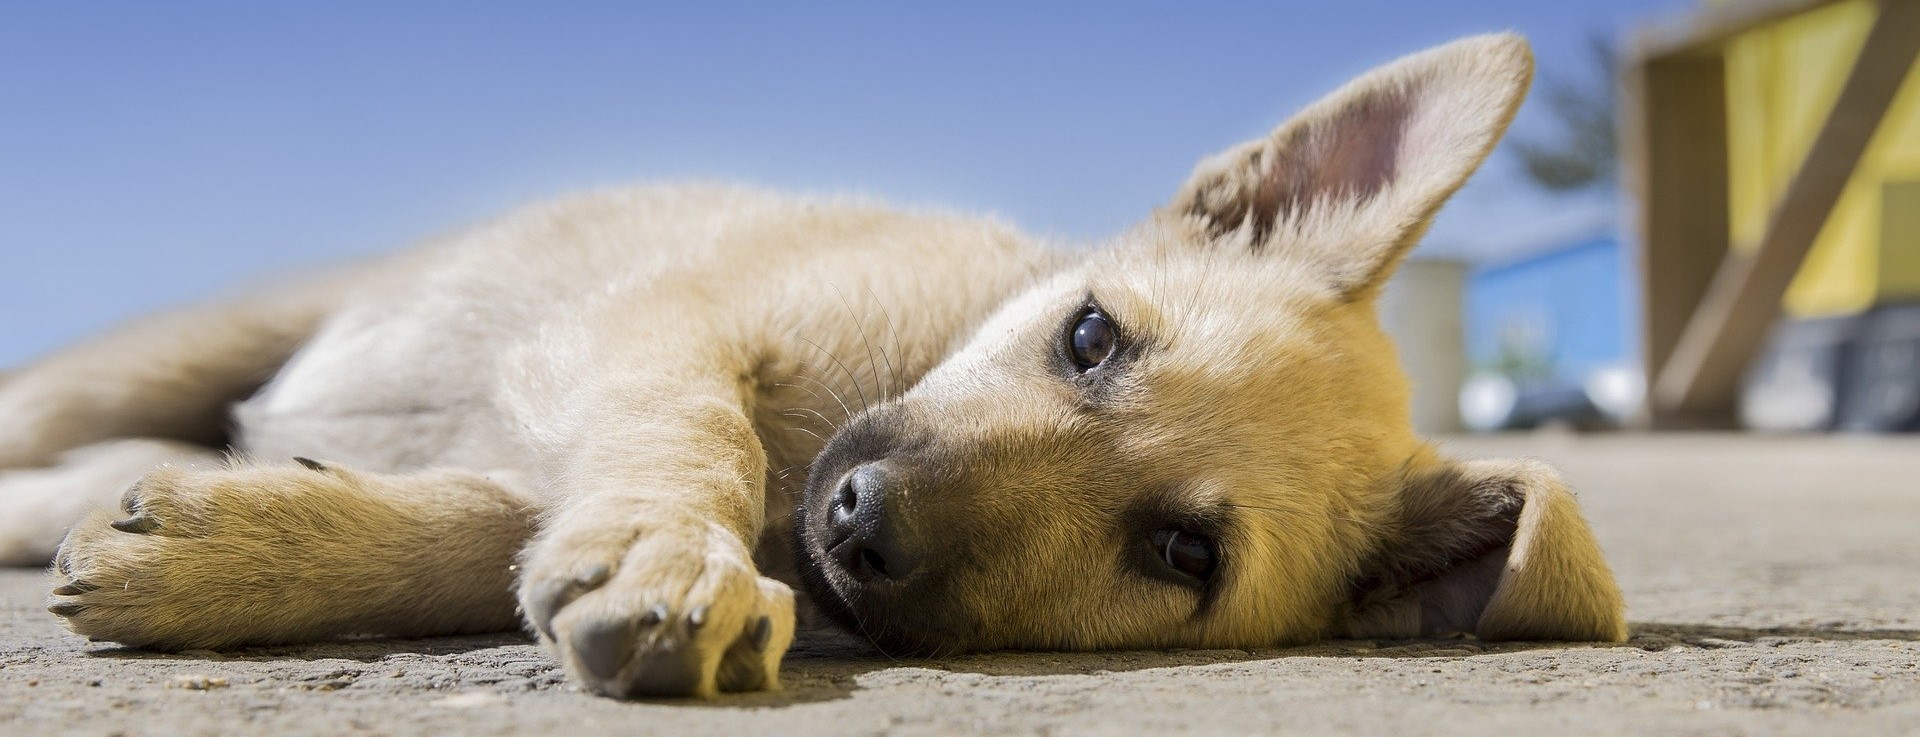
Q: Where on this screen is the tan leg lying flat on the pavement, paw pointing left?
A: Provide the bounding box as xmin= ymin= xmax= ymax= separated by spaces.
xmin=48 ymin=461 xmax=534 ymax=649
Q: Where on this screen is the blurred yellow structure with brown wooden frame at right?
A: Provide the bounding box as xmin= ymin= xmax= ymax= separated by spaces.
xmin=1622 ymin=0 xmax=1920 ymax=430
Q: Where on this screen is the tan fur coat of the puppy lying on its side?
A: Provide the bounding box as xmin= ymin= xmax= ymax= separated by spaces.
xmin=0 ymin=36 xmax=1624 ymax=695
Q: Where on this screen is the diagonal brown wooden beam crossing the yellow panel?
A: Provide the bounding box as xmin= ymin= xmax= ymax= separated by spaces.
xmin=1649 ymin=0 xmax=1920 ymax=415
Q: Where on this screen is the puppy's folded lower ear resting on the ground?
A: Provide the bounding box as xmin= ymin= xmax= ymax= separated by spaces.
xmin=1342 ymin=461 xmax=1626 ymax=643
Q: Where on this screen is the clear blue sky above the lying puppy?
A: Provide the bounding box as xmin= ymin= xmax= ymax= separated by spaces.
xmin=0 ymin=0 xmax=1690 ymax=367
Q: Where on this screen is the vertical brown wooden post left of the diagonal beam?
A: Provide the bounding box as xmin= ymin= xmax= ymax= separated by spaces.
xmin=1620 ymin=56 xmax=1734 ymax=428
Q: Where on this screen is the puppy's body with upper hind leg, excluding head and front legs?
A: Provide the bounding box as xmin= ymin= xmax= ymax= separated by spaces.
xmin=0 ymin=186 xmax=1058 ymax=562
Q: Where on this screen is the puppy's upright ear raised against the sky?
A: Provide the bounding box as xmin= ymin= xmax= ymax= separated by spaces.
xmin=1167 ymin=35 xmax=1534 ymax=296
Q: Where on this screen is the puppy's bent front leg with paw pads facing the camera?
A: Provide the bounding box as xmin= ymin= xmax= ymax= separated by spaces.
xmin=520 ymin=370 xmax=793 ymax=697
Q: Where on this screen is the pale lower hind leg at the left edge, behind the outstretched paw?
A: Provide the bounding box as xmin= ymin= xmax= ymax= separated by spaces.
xmin=0 ymin=438 xmax=221 ymax=566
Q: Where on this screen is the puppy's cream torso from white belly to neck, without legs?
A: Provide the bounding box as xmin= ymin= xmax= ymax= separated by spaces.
xmin=240 ymin=186 xmax=1046 ymax=472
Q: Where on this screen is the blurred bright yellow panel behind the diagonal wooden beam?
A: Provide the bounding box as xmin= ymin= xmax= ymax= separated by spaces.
xmin=1726 ymin=0 xmax=1920 ymax=317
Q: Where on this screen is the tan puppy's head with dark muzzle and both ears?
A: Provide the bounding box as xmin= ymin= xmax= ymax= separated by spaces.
xmin=797 ymin=36 xmax=1624 ymax=651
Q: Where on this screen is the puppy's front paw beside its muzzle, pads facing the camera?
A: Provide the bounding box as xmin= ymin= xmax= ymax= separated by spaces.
xmin=520 ymin=520 xmax=793 ymax=699
